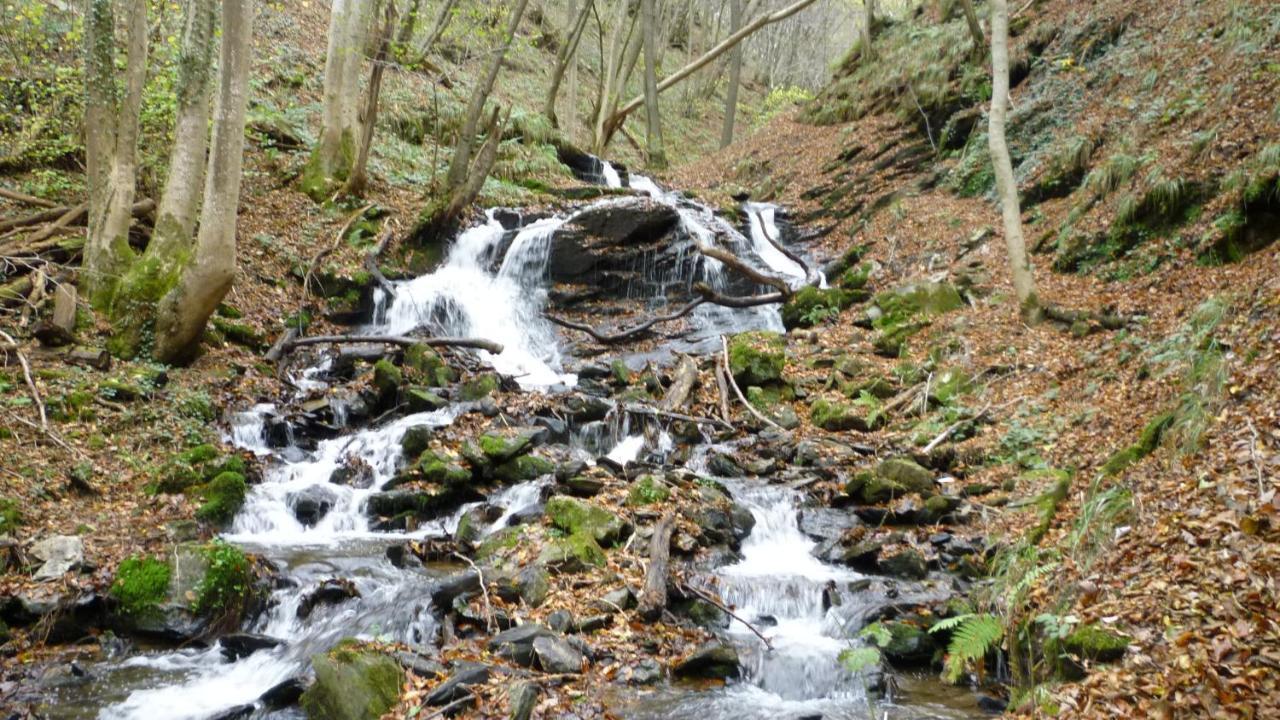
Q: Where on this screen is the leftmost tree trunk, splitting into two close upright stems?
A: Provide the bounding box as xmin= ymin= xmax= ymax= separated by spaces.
xmin=83 ymin=0 xmax=147 ymax=307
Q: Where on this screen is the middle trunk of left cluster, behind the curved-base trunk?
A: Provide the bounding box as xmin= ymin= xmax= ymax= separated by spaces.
xmin=147 ymin=0 xmax=218 ymax=256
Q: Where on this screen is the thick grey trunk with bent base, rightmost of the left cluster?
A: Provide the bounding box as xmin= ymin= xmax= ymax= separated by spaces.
xmin=155 ymin=0 xmax=253 ymax=361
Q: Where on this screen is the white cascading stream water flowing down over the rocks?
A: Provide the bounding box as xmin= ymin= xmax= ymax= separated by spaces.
xmin=42 ymin=163 xmax=980 ymax=720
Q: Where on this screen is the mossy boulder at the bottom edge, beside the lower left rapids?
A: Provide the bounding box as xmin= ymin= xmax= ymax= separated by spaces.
xmin=302 ymin=641 xmax=404 ymax=720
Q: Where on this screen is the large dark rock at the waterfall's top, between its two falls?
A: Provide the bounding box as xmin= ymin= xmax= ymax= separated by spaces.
xmin=547 ymin=197 xmax=680 ymax=288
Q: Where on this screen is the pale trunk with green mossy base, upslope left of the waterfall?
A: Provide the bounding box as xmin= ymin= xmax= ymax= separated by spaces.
xmin=302 ymin=0 xmax=366 ymax=202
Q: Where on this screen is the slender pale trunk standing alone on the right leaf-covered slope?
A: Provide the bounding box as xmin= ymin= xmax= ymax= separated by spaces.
xmin=988 ymin=0 xmax=1042 ymax=323
